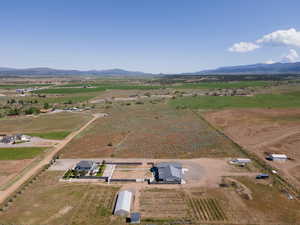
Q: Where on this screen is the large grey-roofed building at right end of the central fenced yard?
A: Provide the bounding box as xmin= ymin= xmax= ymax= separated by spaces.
xmin=152 ymin=162 xmax=182 ymax=184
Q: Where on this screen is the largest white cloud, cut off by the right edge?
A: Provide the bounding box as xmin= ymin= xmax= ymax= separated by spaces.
xmin=256 ymin=28 xmax=300 ymax=47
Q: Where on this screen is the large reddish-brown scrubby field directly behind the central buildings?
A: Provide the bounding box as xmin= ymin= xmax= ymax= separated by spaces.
xmin=62 ymin=103 xmax=241 ymax=158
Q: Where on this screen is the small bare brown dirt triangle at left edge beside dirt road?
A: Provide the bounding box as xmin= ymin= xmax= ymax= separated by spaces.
xmin=0 ymin=159 xmax=32 ymax=186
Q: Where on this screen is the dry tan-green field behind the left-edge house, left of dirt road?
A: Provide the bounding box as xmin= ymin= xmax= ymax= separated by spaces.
xmin=0 ymin=113 xmax=91 ymax=134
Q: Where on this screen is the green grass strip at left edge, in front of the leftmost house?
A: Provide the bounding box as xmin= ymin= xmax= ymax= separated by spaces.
xmin=0 ymin=147 xmax=46 ymax=160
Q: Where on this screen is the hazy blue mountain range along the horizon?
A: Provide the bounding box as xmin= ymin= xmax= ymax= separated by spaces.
xmin=0 ymin=62 xmax=300 ymax=76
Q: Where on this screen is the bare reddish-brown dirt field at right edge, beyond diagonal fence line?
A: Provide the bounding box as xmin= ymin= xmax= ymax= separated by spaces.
xmin=205 ymin=109 xmax=300 ymax=188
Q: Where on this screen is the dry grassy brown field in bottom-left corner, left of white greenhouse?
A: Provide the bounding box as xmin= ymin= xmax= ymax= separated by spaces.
xmin=0 ymin=172 xmax=124 ymax=225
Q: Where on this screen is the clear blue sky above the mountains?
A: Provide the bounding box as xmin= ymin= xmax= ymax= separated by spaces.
xmin=0 ymin=0 xmax=300 ymax=73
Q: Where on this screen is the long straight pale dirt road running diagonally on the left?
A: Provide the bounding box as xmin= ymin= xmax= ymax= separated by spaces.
xmin=0 ymin=114 xmax=102 ymax=204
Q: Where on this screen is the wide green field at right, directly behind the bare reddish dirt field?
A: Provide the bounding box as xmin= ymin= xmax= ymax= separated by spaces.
xmin=170 ymin=92 xmax=300 ymax=109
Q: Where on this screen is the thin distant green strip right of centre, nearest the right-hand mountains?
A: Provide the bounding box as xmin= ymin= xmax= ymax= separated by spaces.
xmin=175 ymin=81 xmax=270 ymax=89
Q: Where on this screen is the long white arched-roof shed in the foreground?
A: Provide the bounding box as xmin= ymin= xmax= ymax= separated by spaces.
xmin=114 ymin=190 xmax=133 ymax=216
